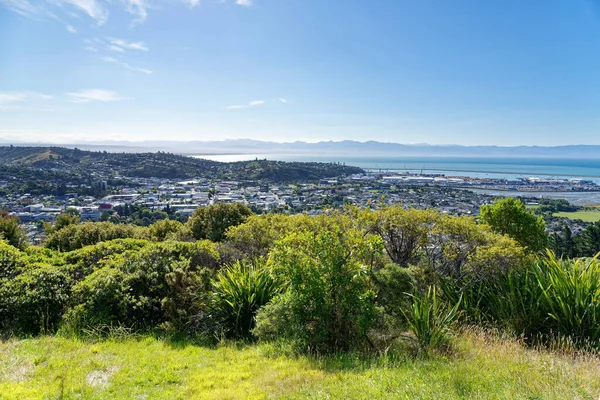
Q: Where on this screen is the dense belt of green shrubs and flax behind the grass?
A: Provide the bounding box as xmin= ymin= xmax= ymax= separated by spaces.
xmin=0 ymin=202 xmax=600 ymax=354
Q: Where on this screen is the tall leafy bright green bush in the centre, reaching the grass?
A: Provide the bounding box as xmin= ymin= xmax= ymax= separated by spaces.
xmin=255 ymin=226 xmax=382 ymax=352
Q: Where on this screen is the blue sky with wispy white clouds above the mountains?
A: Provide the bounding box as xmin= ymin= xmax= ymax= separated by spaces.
xmin=0 ymin=0 xmax=600 ymax=145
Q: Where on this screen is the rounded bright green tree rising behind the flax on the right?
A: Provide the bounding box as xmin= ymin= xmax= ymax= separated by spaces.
xmin=480 ymin=197 xmax=548 ymax=252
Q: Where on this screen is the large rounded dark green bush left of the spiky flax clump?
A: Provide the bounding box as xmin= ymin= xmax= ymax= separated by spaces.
xmin=69 ymin=242 xmax=218 ymax=330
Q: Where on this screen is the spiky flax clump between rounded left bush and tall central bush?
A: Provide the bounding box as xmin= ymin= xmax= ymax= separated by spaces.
xmin=211 ymin=259 xmax=283 ymax=337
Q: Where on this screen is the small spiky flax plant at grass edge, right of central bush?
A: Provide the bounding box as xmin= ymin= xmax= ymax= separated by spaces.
xmin=402 ymin=286 xmax=460 ymax=354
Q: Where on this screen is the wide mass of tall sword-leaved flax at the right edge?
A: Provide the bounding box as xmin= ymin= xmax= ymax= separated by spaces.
xmin=441 ymin=252 xmax=600 ymax=347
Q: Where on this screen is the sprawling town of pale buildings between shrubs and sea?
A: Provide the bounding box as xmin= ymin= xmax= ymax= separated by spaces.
xmin=0 ymin=160 xmax=600 ymax=242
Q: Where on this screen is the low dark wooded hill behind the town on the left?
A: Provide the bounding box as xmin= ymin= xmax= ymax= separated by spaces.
xmin=0 ymin=146 xmax=362 ymax=182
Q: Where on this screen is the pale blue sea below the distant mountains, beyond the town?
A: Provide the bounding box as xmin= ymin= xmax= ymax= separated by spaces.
xmin=194 ymin=154 xmax=600 ymax=184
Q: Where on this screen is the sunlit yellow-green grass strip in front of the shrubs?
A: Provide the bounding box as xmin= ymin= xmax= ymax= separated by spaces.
xmin=0 ymin=332 xmax=600 ymax=400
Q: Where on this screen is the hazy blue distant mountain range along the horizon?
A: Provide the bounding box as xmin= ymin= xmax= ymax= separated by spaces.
xmin=0 ymin=139 xmax=600 ymax=158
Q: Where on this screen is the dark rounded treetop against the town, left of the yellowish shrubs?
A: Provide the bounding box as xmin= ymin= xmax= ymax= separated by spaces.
xmin=186 ymin=203 xmax=252 ymax=242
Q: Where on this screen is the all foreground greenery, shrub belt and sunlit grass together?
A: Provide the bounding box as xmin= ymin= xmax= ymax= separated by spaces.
xmin=0 ymin=199 xmax=600 ymax=398
